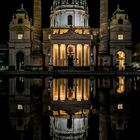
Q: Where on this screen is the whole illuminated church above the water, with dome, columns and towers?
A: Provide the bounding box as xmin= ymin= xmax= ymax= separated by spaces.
xmin=8 ymin=0 xmax=132 ymax=70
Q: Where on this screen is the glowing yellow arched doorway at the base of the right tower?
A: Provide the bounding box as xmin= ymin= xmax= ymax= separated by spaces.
xmin=117 ymin=51 xmax=125 ymax=70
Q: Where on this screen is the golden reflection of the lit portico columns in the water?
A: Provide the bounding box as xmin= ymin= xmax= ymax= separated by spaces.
xmin=52 ymin=78 xmax=90 ymax=101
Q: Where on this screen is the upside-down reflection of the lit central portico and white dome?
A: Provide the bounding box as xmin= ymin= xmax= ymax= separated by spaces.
xmin=49 ymin=78 xmax=93 ymax=140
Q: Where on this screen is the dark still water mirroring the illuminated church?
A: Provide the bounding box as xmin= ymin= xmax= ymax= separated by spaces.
xmin=0 ymin=76 xmax=140 ymax=140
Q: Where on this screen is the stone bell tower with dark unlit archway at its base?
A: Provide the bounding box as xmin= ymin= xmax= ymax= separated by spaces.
xmin=9 ymin=4 xmax=31 ymax=70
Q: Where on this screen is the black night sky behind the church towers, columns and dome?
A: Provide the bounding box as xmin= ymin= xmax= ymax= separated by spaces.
xmin=0 ymin=0 xmax=140 ymax=42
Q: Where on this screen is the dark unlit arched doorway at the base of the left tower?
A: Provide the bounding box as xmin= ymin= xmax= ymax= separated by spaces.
xmin=16 ymin=52 xmax=24 ymax=70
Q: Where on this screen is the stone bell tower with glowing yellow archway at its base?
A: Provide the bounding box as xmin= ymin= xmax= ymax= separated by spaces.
xmin=110 ymin=5 xmax=132 ymax=70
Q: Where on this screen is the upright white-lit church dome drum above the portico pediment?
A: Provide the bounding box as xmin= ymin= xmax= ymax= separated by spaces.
xmin=50 ymin=0 xmax=89 ymax=27
